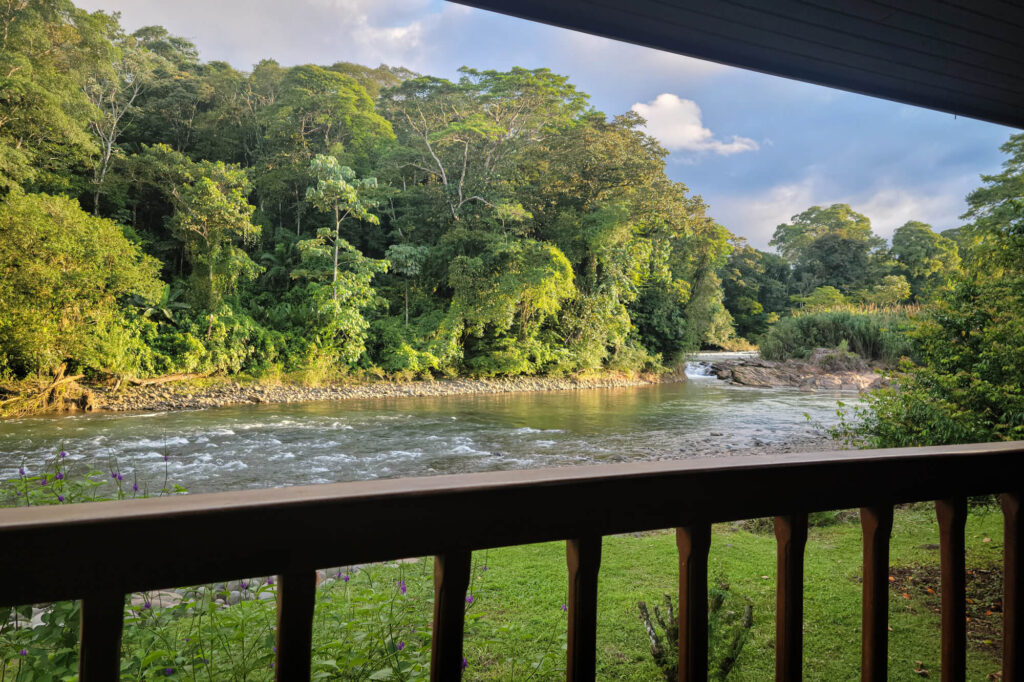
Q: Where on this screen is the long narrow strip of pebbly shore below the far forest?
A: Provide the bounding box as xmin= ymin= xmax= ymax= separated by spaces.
xmin=90 ymin=368 xmax=685 ymax=412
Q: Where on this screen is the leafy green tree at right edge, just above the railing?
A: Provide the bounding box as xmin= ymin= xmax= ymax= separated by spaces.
xmin=840 ymin=134 xmax=1024 ymax=446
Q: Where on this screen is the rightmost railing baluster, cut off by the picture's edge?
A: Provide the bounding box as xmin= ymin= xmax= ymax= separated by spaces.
xmin=999 ymin=494 xmax=1024 ymax=682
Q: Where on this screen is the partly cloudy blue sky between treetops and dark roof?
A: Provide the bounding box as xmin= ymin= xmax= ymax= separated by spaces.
xmin=77 ymin=0 xmax=1015 ymax=248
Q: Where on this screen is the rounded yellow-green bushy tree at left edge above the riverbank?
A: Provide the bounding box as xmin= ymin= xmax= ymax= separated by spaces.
xmin=0 ymin=189 xmax=160 ymax=374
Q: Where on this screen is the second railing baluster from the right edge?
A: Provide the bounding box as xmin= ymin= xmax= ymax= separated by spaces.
xmin=935 ymin=498 xmax=967 ymax=682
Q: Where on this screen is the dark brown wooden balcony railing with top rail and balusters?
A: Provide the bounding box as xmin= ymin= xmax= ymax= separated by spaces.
xmin=0 ymin=442 xmax=1024 ymax=682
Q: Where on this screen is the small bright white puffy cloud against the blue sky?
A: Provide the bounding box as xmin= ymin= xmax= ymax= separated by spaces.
xmin=632 ymin=92 xmax=758 ymax=156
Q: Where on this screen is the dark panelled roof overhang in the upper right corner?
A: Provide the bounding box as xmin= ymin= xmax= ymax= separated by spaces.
xmin=455 ymin=0 xmax=1024 ymax=128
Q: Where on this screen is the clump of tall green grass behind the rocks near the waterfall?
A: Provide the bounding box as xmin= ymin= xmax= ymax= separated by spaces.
xmin=760 ymin=308 xmax=916 ymax=367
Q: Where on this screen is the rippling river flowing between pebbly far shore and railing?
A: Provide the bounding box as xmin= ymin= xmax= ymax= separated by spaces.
xmin=0 ymin=357 xmax=851 ymax=493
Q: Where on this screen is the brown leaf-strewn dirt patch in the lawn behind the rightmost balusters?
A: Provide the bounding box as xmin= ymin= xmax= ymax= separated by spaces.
xmin=889 ymin=566 xmax=1002 ymax=657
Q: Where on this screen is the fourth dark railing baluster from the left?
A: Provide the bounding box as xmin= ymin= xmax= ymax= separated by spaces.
xmin=565 ymin=536 xmax=601 ymax=682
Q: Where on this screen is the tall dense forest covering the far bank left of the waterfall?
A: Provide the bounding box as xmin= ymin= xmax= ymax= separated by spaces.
xmin=0 ymin=0 xmax=733 ymax=378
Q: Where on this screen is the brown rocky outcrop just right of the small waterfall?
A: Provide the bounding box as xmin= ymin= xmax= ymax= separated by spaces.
xmin=711 ymin=348 xmax=887 ymax=391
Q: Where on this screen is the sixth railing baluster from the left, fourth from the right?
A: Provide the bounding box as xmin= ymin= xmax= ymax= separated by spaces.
xmin=775 ymin=513 xmax=807 ymax=682
